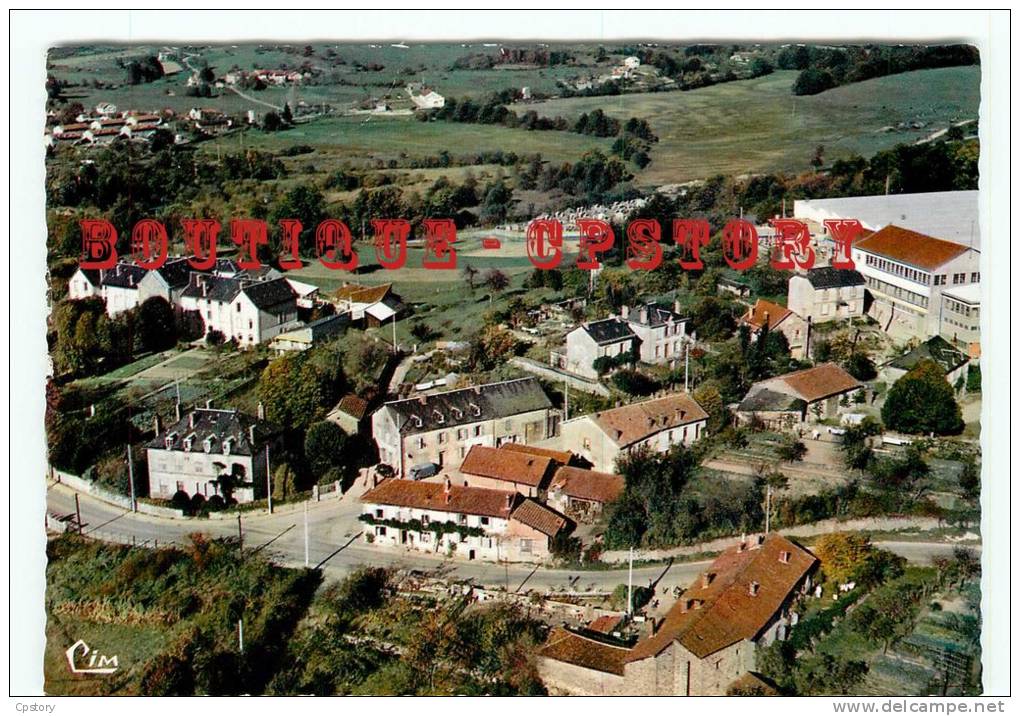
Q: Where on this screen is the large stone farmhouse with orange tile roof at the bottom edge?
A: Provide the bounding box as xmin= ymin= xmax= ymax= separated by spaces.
xmin=538 ymin=533 xmax=818 ymax=696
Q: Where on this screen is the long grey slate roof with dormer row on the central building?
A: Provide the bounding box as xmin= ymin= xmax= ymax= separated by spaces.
xmin=380 ymin=377 xmax=553 ymax=434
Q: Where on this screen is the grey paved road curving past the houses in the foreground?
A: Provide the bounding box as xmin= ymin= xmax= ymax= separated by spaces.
xmin=47 ymin=483 xmax=980 ymax=592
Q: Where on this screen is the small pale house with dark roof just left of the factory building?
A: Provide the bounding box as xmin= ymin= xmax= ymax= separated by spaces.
xmin=786 ymin=266 xmax=865 ymax=323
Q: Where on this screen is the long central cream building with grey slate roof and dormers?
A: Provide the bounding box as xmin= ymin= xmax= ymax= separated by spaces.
xmin=372 ymin=377 xmax=560 ymax=476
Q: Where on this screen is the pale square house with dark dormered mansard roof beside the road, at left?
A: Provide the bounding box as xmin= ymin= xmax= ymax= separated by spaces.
xmin=146 ymin=408 xmax=276 ymax=503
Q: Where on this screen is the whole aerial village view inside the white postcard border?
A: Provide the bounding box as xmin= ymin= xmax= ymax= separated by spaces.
xmin=40 ymin=40 xmax=981 ymax=696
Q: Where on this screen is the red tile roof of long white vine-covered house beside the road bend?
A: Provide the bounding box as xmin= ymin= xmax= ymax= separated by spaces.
xmin=361 ymin=479 xmax=517 ymax=519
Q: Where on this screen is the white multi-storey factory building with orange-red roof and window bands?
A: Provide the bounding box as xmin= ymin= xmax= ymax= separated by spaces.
xmin=851 ymin=225 xmax=981 ymax=338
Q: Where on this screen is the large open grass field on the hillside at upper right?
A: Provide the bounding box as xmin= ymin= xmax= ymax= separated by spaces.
xmin=533 ymin=67 xmax=980 ymax=185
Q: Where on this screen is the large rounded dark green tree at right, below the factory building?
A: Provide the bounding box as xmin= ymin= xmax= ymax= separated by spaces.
xmin=882 ymin=359 xmax=964 ymax=436
